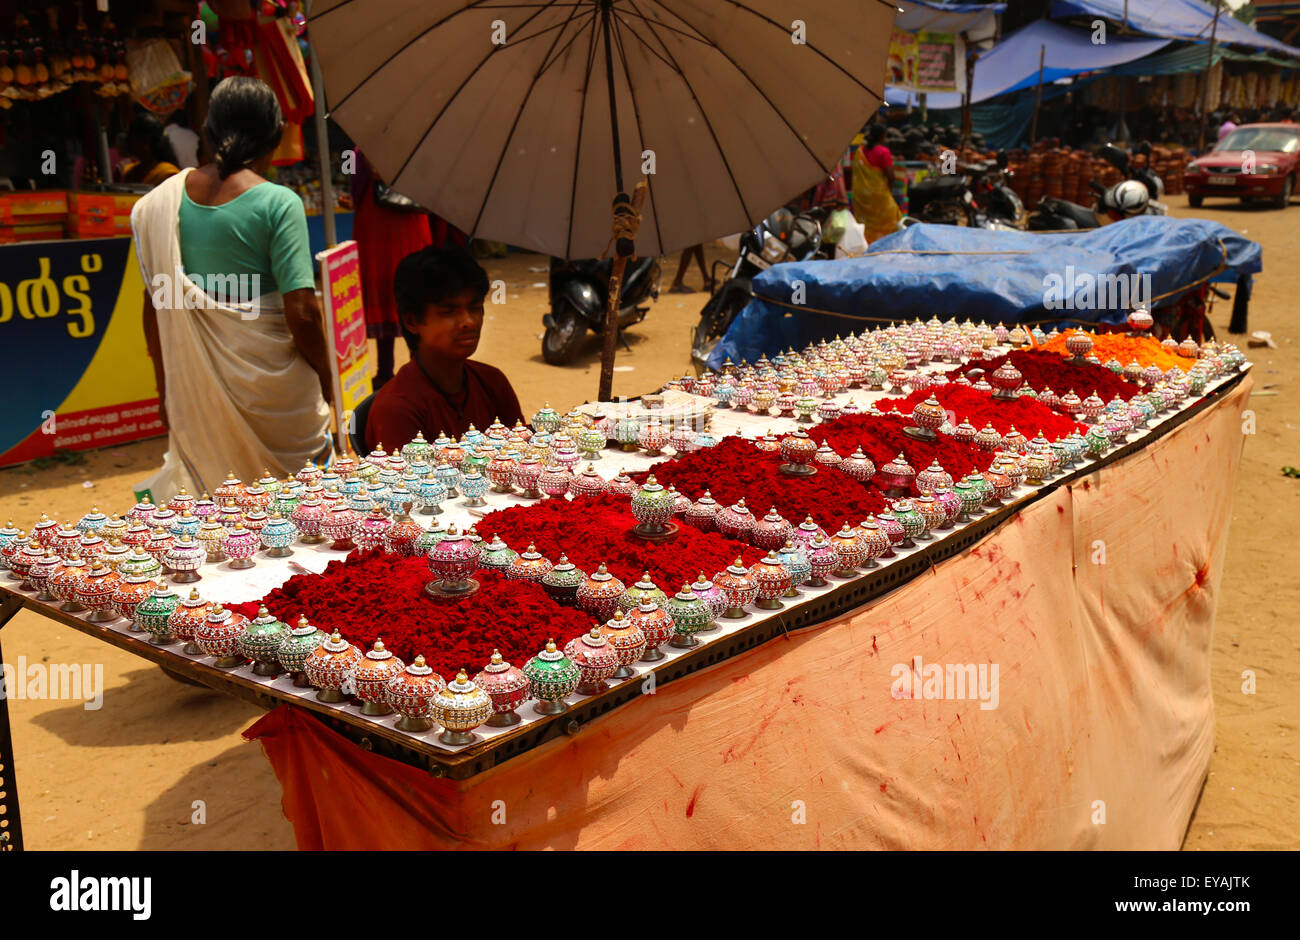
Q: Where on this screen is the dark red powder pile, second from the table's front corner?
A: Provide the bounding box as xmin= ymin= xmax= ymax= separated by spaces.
xmin=477 ymin=495 xmax=759 ymax=594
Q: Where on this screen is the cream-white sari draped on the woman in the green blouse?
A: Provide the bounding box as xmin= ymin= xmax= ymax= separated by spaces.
xmin=131 ymin=169 xmax=329 ymax=503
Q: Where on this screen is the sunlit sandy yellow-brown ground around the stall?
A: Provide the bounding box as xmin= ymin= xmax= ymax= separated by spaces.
xmin=0 ymin=205 xmax=1300 ymax=849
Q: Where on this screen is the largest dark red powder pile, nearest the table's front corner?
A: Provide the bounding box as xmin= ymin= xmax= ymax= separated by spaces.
xmin=231 ymin=550 xmax=593 ymax=680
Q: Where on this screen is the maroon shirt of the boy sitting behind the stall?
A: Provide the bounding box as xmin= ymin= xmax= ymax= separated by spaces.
xmin=365 ymin=359 xmax=524 ymax=450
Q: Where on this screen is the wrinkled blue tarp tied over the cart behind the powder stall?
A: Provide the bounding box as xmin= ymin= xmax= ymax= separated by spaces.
xmin=709 ymin=216 xmax=1261 ymax=368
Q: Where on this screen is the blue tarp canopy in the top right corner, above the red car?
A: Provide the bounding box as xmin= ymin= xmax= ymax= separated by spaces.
xmin=1052 ymin=0 xmax=1300 ymax=59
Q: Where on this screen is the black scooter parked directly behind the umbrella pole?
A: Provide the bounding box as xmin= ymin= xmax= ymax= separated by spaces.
xmin=542 ymin=257 xmax=662 ymax=365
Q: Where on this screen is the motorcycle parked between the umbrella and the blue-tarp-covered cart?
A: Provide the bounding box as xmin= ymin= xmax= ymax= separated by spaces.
xmin=690 ymin=208 xmax=827 ymax=367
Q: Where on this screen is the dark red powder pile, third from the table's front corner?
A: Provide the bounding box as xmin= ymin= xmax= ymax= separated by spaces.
xmin=632 ymin=428 xmax=885 ymax=525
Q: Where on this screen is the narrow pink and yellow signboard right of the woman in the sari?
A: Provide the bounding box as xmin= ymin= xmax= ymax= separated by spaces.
xmin=316 ymin=242 xmax=372 ymax=438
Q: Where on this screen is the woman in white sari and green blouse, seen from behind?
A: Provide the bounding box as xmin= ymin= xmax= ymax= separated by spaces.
xmin=131 ymin=77 xmax=330 ymax=502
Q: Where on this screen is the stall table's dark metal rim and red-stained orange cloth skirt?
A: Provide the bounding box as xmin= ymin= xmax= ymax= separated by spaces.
xmin=0 ymin=348 xmax=1249 ymax=848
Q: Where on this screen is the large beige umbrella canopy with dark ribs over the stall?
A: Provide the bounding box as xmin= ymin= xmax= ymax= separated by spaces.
xmin=309 ymin=0 xmax=897 ymax=257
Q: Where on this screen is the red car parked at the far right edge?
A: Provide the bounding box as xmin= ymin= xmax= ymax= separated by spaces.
xmin=1183 ymin=124 xmax=1300 ymax=209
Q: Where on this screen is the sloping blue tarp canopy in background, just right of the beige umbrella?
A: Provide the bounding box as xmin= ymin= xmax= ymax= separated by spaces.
xmin=885 ymin=20 xmax=1170 ymax=109
